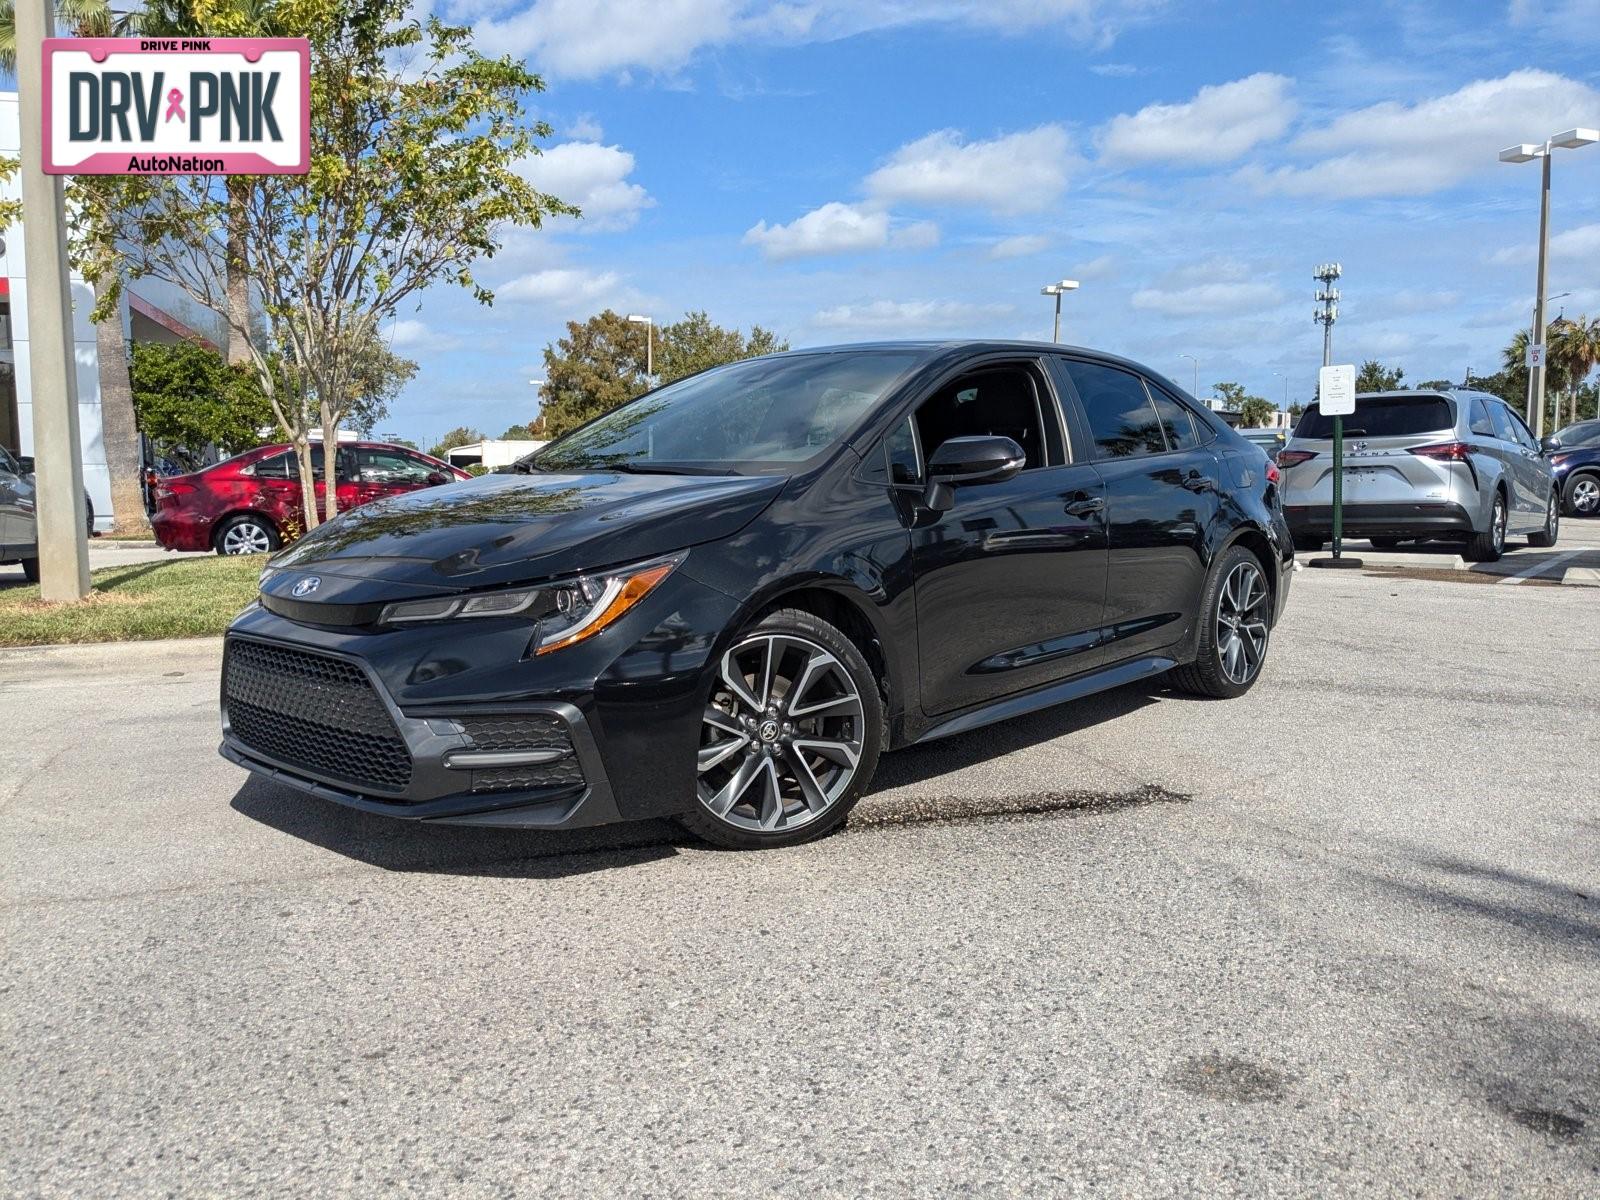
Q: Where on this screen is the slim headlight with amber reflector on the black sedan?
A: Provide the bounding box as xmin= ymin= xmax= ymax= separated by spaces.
xmin=378 ymin=554 xmax=683 ymax=654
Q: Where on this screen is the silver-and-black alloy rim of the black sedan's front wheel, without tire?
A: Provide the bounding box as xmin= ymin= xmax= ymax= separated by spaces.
xmin=698 ymin=634 xmax=866 ymax=832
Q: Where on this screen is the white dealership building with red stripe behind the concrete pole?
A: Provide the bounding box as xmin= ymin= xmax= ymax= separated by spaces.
xmin=0 ymin=91 xmax=227 ymax=530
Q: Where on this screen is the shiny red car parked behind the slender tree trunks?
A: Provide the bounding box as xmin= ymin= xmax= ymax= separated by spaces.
xmin=150 ymin=442 xmax=472 ymax=554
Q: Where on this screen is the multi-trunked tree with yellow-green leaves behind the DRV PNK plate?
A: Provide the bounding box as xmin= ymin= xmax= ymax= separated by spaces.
xmin=80 ymin=0 xmax=576 ymax=528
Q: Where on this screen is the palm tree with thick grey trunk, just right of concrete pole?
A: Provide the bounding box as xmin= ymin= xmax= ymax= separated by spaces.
xmin=0 ymin=0 xmax=150 ymax=534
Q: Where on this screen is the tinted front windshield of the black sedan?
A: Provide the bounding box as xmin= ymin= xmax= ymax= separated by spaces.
xmin=520 ymin=350 xmax=918 ymax=474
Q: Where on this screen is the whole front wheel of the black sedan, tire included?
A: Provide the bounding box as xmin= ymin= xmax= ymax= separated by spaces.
xmin=680 ymin=608 xmax=883 ymax=850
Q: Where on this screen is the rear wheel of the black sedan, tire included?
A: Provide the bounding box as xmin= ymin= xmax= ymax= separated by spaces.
xmin=1171 ymin=546 xmax=1272 ymax=699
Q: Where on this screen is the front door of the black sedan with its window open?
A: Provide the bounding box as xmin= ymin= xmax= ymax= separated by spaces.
xmin=896 ymin=358 xmax=1106 ymax=715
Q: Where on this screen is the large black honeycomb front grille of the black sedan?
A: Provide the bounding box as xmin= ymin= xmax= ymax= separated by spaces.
xmin=222 ymin=638 xmax=411 ymax=792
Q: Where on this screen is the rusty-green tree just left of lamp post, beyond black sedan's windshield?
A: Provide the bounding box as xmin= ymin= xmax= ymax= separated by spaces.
xmin=534 ymin=309 xmax=650 ymax=437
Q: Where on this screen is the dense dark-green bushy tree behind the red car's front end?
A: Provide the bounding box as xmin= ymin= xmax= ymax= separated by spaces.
xmin=130 ymin=341 xmax=275 ymax=454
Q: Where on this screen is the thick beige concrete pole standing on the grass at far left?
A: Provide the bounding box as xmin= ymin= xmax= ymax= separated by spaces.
xmin=16 ymin=0 xmax=90 ymax=602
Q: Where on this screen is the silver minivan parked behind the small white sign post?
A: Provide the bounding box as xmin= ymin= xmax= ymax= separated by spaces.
xmin=1278 ymin=390 xmax=1560 ymax=562
